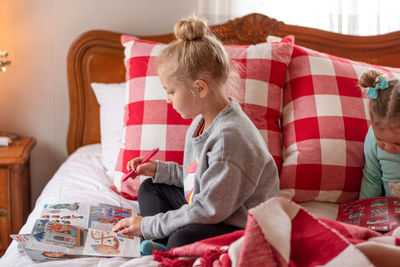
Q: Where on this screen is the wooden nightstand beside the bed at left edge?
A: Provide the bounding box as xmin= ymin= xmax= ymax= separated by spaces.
xmin=0 ymin=137 xmax=36 ymax=256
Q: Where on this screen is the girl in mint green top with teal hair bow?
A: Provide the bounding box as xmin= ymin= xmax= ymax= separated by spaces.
xmin=359 ymin=70 xmax=400 ymax=199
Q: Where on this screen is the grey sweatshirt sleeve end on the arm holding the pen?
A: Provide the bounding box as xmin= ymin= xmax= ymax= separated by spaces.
xmin=153 ymin=161 xmax=183 ymax=187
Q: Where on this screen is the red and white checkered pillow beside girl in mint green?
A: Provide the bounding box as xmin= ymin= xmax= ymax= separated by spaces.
xmin=280 ymin=45 xmax=400 ymax=203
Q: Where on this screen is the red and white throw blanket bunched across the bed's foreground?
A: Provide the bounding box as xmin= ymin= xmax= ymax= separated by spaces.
xmin=154 ymin=197 xmax=400 ymax=267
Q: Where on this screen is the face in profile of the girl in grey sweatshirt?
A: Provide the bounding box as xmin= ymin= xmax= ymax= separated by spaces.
xmin=159 ymin=71 xmax=200 ymax=119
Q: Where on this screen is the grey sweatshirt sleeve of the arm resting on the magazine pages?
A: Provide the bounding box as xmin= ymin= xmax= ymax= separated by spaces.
xmin=141 ymin=161 xmax=258 ymax=239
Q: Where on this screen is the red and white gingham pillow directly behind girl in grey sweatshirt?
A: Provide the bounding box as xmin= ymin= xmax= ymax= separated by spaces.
xmin=116 ymin=35 xmax=293 ymax=199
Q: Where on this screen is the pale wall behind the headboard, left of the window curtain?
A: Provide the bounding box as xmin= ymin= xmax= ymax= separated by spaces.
xmin=0 ymin=0 xmax=197 ymax=207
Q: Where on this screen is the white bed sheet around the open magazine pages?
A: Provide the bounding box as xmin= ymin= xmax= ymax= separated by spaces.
xmin=0 ymin=144 xmax=158 ymax=267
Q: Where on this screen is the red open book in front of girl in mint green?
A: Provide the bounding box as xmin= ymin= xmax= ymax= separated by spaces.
xmin=337 ymin=197 xmax=400 ymax=232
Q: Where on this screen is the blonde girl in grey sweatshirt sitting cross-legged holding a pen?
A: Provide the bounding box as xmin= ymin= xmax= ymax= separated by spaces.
xmin=113 ymin=17 xmax=279 ymax=255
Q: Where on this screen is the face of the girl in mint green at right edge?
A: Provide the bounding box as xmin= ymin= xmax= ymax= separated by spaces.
xmin=372 ymin=125 xmax=400 ymax=154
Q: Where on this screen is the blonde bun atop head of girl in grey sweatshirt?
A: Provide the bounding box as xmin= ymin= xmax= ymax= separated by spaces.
xmin=174 ymin=16 xmax=207 ymax=41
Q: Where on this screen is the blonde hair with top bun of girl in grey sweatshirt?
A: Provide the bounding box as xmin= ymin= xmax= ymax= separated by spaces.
xmin=157 ymin=16 xmax=230 ymax=98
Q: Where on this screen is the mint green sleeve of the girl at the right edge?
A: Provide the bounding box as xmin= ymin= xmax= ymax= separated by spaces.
xmin=360 ymin=128 xmax=383 ymax=199
